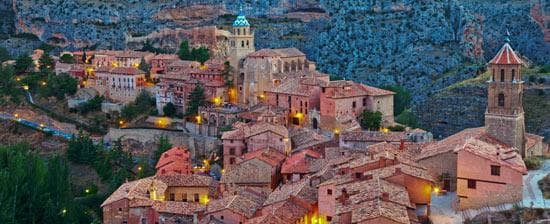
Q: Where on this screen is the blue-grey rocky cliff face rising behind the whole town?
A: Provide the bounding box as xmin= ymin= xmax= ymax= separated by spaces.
xmin=0 ymin=0 xmax=550 ymax=137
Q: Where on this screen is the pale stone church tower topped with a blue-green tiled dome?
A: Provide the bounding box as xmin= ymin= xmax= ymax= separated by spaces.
xmin=229 ymin=13 xmax=256 ymax=103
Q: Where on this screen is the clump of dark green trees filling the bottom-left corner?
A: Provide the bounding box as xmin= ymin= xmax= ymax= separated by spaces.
xmin=0 ymin=144 xmax=92 ymax=224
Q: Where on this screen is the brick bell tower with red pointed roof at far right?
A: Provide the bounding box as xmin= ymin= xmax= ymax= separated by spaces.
xmin=485 ymin=32 xmax=525 ymax=157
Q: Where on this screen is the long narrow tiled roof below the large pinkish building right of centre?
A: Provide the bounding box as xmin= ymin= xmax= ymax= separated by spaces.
xmin=340 ymin=131 xmax=407 ymax=142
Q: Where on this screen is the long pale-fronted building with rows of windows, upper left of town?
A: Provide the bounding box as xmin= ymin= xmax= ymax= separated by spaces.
xmin=91 ymin=66 xmax=145 ymax=104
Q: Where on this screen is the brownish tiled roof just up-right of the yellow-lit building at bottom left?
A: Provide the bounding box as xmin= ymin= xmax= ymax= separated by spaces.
xmin=220 ymin=158 xmax=275 ymax=184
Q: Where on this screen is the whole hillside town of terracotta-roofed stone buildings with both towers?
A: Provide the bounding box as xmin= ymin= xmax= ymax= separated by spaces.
xmin=0 ymin=9 xmax=550 ymax=224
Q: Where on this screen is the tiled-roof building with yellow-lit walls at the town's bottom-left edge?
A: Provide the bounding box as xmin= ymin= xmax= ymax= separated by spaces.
xmin=101 ymin=174 xmax=218 ymax=224
